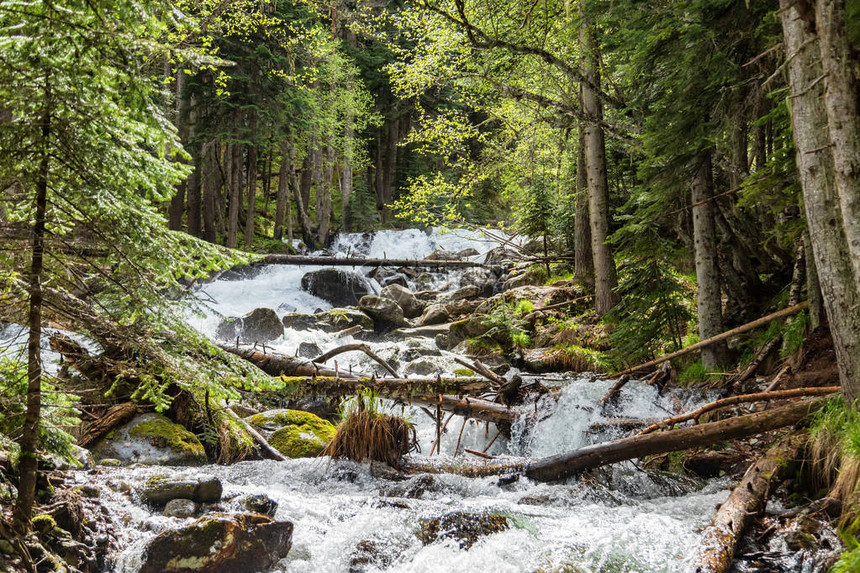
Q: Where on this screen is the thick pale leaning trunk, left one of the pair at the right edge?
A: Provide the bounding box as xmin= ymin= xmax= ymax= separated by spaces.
xmin=780 ymin=0 xmax=860 ymax=403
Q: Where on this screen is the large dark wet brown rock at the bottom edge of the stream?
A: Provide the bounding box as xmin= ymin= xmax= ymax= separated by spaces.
xmin=140 ymin=514 xmax=293 ymax=573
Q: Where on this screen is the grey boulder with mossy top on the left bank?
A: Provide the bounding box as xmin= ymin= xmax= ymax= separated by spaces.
xmin=92 ymin=414 xmax=206 ymax=466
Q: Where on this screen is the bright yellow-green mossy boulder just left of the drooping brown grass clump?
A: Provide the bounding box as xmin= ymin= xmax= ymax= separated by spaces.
xmin=248 ymin=409 xmax=335 ymax=458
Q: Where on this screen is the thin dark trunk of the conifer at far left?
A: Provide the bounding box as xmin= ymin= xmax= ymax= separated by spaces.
xmin=16 ymin=77 xmax=52 ymax=530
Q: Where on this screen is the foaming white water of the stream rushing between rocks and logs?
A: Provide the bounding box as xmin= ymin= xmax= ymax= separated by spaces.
xmin=40 ymin=231 xmax=828 ymax=573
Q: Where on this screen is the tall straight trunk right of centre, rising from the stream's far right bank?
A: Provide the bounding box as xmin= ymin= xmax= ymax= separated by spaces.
xmin=580 ymin=22 xmax=618 ymax=314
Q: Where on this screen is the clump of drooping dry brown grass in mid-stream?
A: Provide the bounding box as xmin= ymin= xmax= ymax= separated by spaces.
xmin=324 ymin=388 xmax=418 ymax=468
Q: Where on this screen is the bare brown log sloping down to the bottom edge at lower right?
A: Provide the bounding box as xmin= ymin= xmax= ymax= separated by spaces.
xmin=694 ymin=436 xmax=803 ymax=573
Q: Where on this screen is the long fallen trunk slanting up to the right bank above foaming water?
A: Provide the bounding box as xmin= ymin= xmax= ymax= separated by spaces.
xmin=525 ymin=398 xmax=825 ymax=481
